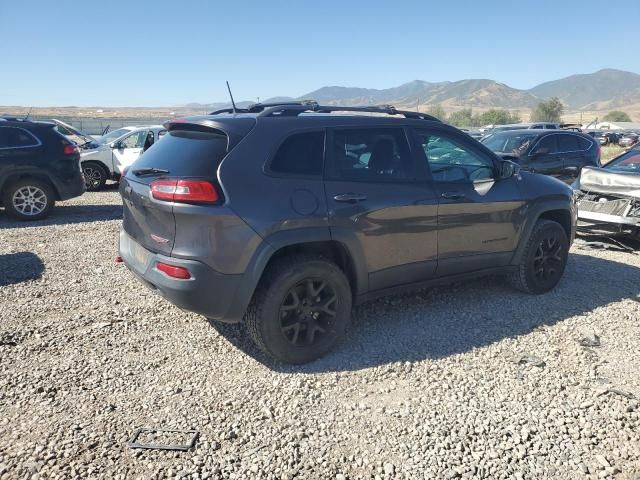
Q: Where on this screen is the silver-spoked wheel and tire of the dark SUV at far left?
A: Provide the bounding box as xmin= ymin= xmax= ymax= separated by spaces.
xmin=2 ymin=178 xmax=55 ymax=220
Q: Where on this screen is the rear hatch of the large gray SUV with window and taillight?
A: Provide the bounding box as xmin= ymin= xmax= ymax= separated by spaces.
xmin=120 ymin=117 xmax=255 ymax=255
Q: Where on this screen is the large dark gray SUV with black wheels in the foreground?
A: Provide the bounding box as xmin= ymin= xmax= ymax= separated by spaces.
xmin=120 ymin=102 xmax=576 ymax=363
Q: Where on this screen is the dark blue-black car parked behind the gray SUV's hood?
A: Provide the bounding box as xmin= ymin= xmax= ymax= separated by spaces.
xmin=482 ymin=130 xmax=600 ymax=184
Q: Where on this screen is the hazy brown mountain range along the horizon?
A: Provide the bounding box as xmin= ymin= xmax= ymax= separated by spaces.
xmin=191 ymin=69 xmax=640 ymax=110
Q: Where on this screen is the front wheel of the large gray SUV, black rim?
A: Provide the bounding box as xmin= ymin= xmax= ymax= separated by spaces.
xmin=508 ymin=220 xmax=569 ymax=294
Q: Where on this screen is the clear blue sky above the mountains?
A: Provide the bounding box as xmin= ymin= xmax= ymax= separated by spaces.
xmin=0 ymin=0 xmax=640 ymax=106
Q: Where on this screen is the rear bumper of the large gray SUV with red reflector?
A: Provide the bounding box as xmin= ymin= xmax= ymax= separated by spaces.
xmin=119 ymin=230 xmax=242 ymax=323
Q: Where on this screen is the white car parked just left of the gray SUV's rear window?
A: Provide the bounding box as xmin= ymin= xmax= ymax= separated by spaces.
xmin=80 ymin=125 xmax=166 ymax=191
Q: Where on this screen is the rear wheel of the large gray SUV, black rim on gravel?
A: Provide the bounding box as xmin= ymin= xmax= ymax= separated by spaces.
xmin=244 ymin=255 xmax=352 ymax=364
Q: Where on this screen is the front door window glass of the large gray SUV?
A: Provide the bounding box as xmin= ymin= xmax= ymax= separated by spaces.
xmin=416 ymin=130 xmax=494 ymax=183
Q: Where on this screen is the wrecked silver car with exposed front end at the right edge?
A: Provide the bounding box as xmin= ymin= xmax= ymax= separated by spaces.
xmin=574 ymin=146 xmax=640 ymax=240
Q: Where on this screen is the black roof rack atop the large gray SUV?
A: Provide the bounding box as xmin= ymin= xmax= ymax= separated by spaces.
xmin=210 ymin=100 xmax=440 ymax=122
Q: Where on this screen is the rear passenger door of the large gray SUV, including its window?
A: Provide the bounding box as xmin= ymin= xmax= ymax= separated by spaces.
xmin=324 ymin=127 xmax=438 ymax=291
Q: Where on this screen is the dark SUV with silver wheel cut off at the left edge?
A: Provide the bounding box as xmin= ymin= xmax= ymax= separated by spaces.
xmin=0 ymin=118 xmax=84 ymax=220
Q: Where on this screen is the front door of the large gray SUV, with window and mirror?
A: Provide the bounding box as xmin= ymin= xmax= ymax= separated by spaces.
xmin=414 ymin=127 xmax=524 ymax=276
